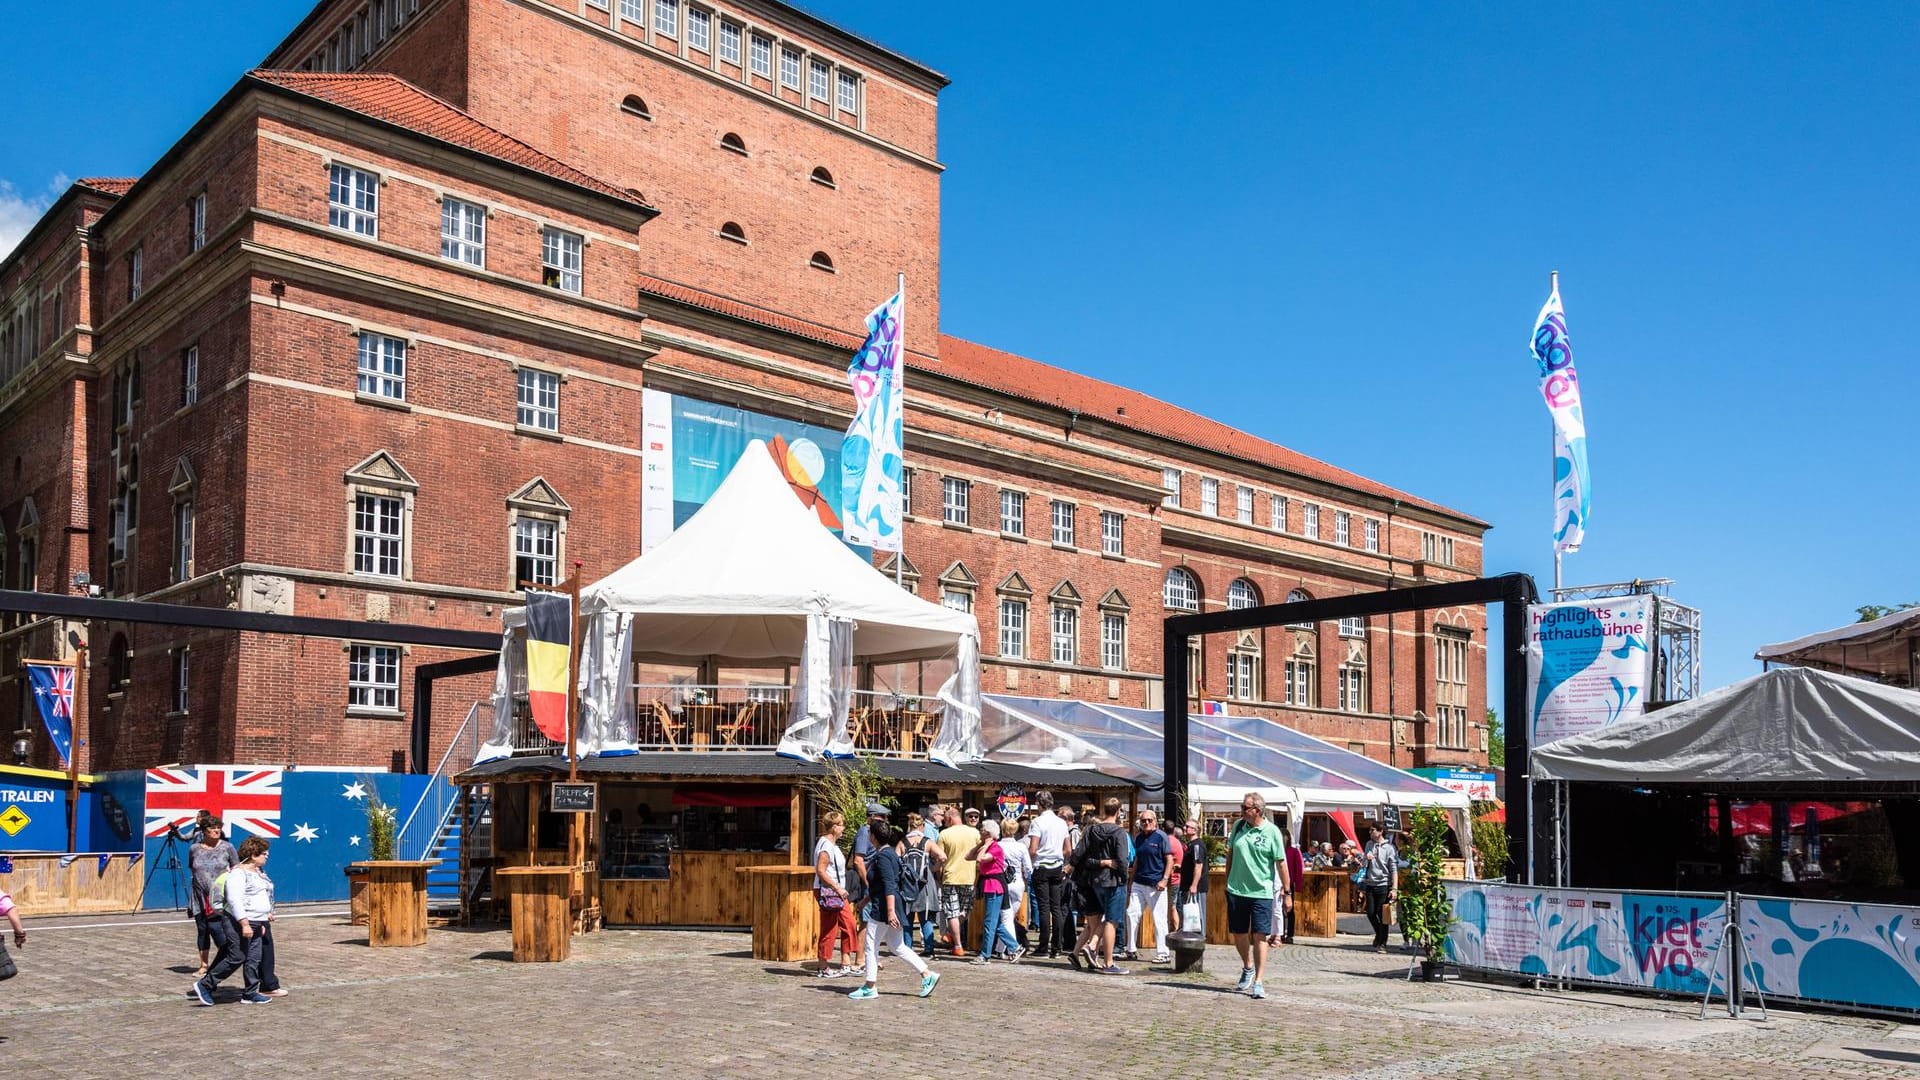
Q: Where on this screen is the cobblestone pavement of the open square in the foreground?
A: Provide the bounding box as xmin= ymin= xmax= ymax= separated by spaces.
xmin=0 ymin=899 xmax=1920 ymax=1080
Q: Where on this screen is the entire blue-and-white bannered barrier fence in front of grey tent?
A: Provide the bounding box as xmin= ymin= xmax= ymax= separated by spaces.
xmin=1446 ymin=882 xmax=1920 ymax=1015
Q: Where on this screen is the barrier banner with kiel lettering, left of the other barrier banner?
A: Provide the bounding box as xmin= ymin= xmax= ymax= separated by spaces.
xmin=1446 ymin=882 xmax=1726 ymax=994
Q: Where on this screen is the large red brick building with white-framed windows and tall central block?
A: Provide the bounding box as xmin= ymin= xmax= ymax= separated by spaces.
xmin=0 ymin=0 xmax=1486 ymax=769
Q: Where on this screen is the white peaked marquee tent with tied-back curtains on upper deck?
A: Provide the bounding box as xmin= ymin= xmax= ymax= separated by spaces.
xmin=480 ymin=440 xmax=979 ymax=765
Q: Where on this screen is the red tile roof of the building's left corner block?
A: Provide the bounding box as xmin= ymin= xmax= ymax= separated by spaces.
xmin=248 ymin=69 xmax=653 ymax=209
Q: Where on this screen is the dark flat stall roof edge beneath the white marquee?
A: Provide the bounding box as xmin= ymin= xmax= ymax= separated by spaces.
xmin=453 ymin=749 xmax=1135 ymax=790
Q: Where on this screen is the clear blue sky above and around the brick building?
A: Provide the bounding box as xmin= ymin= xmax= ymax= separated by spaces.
xmin=0 ymin=0 xmax=1920 ymax=714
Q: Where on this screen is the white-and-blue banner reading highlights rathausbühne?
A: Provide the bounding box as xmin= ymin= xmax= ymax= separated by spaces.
xmin=1526 ymin=596 xmax=1653 ymax=746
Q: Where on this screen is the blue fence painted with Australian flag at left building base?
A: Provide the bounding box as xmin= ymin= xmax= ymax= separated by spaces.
xmin=0 ymin=765 xmax=453 ymax=909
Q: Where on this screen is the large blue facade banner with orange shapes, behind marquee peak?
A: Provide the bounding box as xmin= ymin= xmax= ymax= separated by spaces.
xmin=639 ymin=390 xmax=843 ymax=553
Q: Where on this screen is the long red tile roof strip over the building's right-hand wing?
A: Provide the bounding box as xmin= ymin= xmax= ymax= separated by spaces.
xmin=639 ymin=275 xmax=1486 ymax=525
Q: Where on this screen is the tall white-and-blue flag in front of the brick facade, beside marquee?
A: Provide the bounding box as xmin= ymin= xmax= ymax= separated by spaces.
xmin=839 ymin=290 xmax=906 ymax=552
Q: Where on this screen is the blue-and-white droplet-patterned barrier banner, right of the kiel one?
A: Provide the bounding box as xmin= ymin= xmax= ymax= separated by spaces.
xmin=1740 ymin=896 xmax=1920 ymax=1009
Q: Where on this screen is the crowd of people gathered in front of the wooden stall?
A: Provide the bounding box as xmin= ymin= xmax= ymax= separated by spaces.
xmin=814 ymin=792 xmax=1398 ymax=999
